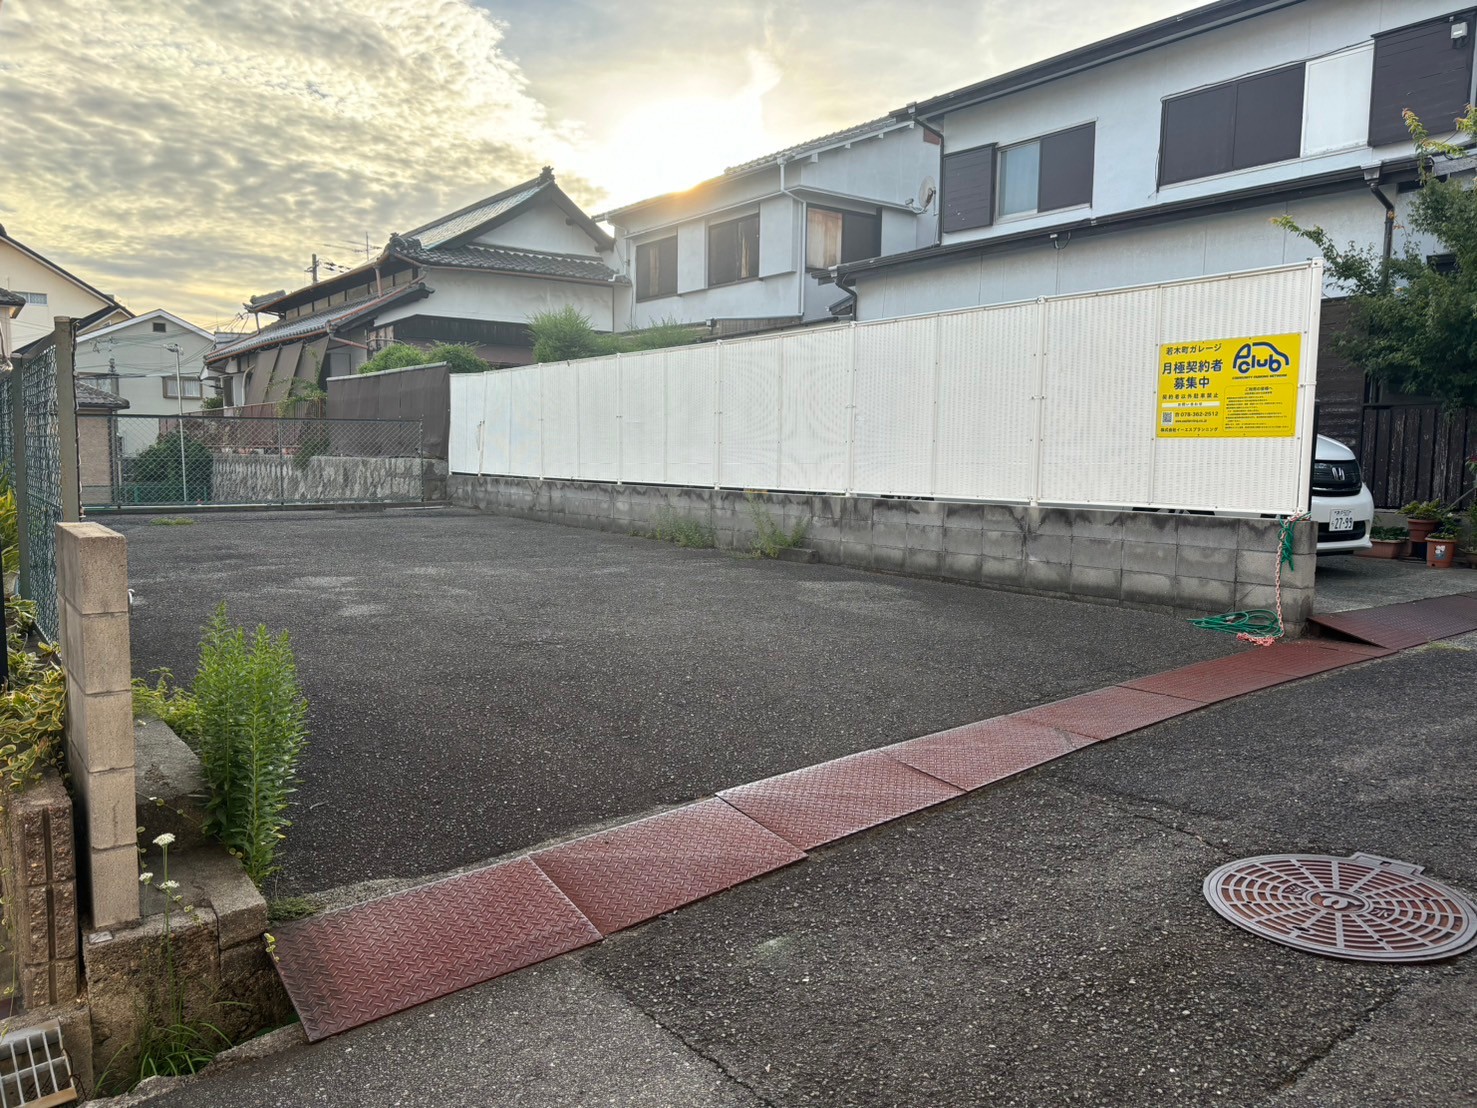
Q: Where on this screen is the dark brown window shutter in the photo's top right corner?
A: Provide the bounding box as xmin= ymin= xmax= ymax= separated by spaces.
xmin=1369 ymin=12 xmax=1477 ymax=146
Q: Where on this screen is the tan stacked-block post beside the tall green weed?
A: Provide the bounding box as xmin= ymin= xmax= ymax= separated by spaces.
xmin=56 ymin=523 xmax=139 ymax=929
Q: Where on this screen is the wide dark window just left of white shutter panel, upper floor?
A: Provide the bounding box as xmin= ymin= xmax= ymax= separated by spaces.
xmin=1159 ymin=62 xmax=1304 ymax=185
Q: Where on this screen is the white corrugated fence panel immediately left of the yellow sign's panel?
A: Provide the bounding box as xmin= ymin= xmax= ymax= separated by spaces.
xmin=1037 ymin=288 xmax=1159 ymax=507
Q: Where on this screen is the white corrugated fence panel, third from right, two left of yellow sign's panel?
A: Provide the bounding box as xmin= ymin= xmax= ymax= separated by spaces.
xmin=933 ymin=304 xmax=1043 ymax=501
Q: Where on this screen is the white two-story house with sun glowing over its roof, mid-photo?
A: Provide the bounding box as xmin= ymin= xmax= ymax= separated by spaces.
xmin=597 ymin=118 xmax=939 ymax=334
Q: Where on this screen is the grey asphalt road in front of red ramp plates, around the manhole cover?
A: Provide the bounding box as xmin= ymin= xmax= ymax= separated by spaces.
xmin=121 ymin=635 xmax=1477 ymax=1108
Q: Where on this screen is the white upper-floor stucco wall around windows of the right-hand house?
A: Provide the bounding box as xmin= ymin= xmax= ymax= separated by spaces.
xmin=935 ymin=0 xmax=1477 ymax=251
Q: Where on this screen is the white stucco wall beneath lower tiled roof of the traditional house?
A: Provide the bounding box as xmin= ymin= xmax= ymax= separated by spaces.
xmin=377 ymin=269 xmax=613 ymax=331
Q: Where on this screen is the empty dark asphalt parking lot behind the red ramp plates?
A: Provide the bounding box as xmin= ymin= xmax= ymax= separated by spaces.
xmin=121 ymin=510 xmax=1235 ymax=892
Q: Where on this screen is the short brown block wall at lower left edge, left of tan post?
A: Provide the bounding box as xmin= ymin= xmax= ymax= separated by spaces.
xmin=0 ymin=770 xmax=78 ymax=1010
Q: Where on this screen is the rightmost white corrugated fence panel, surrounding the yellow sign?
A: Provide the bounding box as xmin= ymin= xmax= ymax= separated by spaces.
xmin=1146 ymin=269 xmax=1322 ymax=513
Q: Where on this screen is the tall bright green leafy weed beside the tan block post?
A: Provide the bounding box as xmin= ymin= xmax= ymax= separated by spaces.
xmin=193 ymin=604 xmax=307 ymax=885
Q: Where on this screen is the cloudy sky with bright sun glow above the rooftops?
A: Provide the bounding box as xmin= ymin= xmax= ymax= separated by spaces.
xmin=0 ymin=0 xmax=1196 ymax=326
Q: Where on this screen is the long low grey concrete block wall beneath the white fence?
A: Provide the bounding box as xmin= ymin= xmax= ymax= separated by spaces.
xmin=449 ymin=474 xmax=1317 ymax=634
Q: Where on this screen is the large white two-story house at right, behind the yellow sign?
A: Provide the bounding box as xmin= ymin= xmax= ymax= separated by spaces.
xmin=836 ymin=0 xmax=1477 ymax=455
